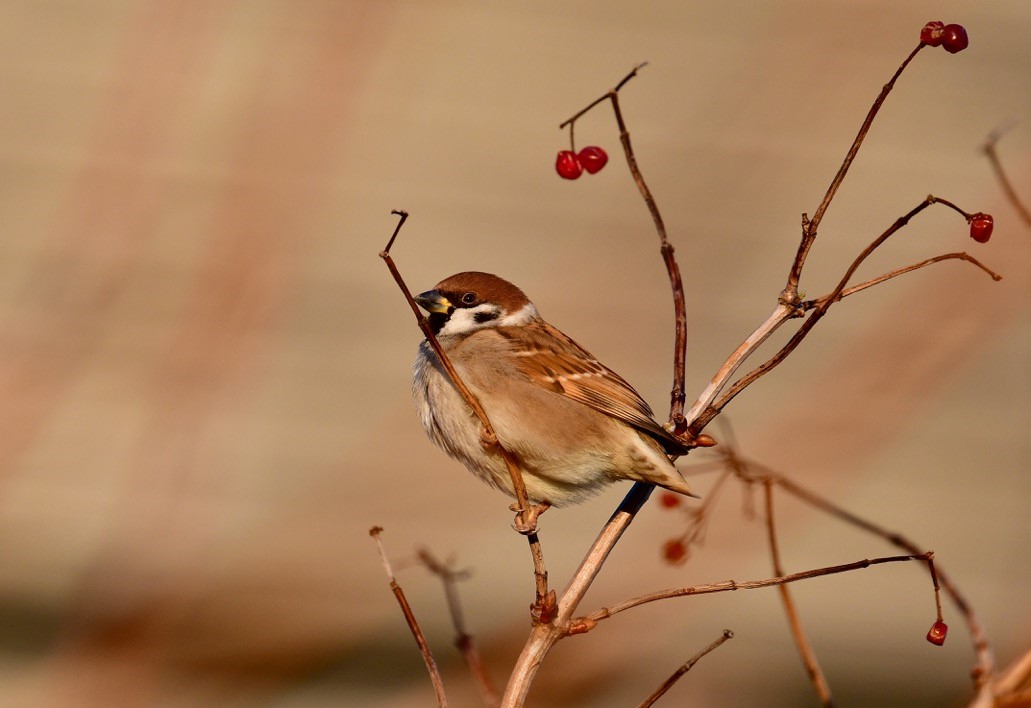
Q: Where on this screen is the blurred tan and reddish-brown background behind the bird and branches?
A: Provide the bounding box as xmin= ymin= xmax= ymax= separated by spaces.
xmin=0 ymin=0 xmax=1031 ymax=707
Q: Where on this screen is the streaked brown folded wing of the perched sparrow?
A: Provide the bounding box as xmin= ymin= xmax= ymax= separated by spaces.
xmin=498 ymin=323 xmax=684 ymax=452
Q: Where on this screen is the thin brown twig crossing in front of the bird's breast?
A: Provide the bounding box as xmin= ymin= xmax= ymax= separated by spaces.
xmin=379 ymin=209 xmax=554 ymax=621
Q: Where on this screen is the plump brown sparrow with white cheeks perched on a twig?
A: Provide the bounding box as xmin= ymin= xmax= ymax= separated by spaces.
xmin=412 ymin=271 xmax=696 ymax=506
